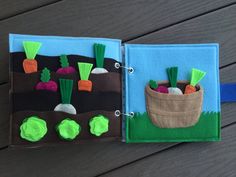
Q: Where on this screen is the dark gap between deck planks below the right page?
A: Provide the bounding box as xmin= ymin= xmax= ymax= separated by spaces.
xmin=95 ymin=121 xmax=236 ymax=177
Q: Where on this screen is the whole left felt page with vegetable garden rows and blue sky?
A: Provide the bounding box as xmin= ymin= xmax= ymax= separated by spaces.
xmin=9 ymin=34 xmax=122 ymax=146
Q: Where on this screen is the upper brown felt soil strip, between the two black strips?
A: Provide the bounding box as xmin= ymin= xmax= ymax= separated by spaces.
xmin=11 ymin=72 xmax=121 ymax=93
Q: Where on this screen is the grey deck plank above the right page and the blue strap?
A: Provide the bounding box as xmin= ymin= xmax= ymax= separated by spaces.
xmin=130 ymin=5 xmax=236 ymax=67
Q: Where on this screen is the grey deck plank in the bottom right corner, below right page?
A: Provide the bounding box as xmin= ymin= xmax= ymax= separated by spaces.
xmin=101 ymin=124 xmax=236 ymax=177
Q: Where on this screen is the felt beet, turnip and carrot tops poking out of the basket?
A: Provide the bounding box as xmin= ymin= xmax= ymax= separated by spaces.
xmin=149 ymin=67 xmax=206 ymax=95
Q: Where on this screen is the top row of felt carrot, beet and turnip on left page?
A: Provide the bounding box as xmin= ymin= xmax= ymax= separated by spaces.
xmin=23 ymin=41 xmax=108 ymax=74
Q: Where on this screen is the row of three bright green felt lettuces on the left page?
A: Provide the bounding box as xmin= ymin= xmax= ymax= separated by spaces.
xmin=20 ymin=115 xmax=109 ymax=142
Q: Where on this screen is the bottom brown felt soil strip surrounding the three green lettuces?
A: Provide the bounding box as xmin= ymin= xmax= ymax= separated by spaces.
xmin=11 ymin=110 xmax=121 ymax=146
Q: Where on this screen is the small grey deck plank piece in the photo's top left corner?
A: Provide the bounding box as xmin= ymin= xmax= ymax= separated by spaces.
xmin=0 ymin=0 xmax=58 ymax=21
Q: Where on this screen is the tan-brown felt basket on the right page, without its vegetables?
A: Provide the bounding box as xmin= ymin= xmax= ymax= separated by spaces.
xmin=145 ymin=81 xmax=203 ymax=128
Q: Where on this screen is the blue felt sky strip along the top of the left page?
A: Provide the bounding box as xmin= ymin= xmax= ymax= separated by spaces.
xmin=9 ymin=34 xmax=122 ymax=62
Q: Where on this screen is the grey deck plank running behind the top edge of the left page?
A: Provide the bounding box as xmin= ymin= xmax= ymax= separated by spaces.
xmin=0 ymin=0 xmax=236 ymax=83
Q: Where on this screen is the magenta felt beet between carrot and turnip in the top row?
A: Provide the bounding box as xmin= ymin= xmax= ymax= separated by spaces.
xmin=56 ymin=55 xmax=75 ymax=74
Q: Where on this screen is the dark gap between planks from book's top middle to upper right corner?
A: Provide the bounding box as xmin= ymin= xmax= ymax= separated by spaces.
xmin=122 ymin=2 xmax=236 ymax=43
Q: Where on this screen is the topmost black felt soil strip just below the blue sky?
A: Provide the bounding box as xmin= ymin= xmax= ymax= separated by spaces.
xmin=10 ymin=52 xmax=121 ymax=73
